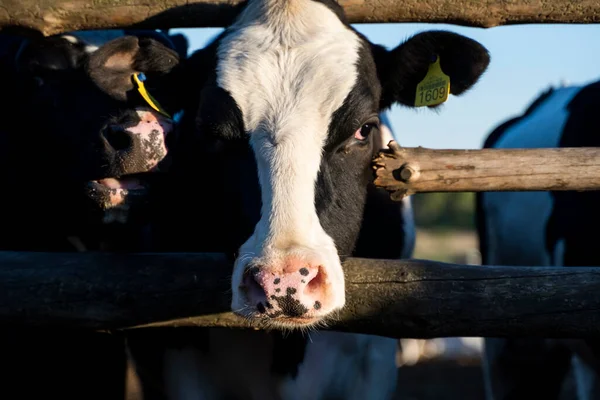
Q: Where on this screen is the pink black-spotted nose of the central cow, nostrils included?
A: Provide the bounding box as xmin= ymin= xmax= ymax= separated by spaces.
xmin=241 ymin=261 xmax=327 ymax=318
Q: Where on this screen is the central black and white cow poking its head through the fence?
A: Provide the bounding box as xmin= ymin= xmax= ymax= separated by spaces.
xmin=130 ymin=0 xmax=489 ymax=399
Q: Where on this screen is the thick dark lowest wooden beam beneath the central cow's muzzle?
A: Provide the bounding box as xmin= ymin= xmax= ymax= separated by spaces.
xmin=0 ymin=252 xmax=600 ymax=338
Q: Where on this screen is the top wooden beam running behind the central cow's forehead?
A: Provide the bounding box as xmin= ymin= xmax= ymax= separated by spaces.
xmin=0 ymin=0 xmax=600 ymax=35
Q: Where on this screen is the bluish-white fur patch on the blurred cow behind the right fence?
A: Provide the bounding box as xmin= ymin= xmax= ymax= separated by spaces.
xmin=482 ymin=87 xmax=581 ymax=266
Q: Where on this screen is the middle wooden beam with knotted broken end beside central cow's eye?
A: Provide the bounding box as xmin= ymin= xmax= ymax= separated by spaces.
xmin=374 ymin=141 xmax=600 ymax=201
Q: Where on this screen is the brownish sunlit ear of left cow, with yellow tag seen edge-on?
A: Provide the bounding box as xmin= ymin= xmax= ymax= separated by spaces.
xmin=87 ymin=36 xmax=179 ymax=101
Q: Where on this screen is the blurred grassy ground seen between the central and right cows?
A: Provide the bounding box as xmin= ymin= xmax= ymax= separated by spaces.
xmin=396 ymin=193 xmax=485 ymax=400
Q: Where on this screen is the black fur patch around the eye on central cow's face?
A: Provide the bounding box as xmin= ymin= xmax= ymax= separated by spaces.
xmin=315 ymin=40 xmax=381 ymax=258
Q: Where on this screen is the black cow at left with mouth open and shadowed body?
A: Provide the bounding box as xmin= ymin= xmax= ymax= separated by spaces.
xmin=0 ymin=31 xmax=187 ymax=399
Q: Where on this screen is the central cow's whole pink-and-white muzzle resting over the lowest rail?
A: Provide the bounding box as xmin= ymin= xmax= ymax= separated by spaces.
xmin=232 ymin=246 xmax=345 ymax=328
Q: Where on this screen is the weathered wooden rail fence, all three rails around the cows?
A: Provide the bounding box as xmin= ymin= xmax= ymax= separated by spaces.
xmin=0 ymin=0 xmax=600 ymax=338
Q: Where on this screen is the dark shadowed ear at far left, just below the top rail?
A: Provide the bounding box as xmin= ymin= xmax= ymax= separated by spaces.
xmin=15 ymin=35 xmax=86 ymax=85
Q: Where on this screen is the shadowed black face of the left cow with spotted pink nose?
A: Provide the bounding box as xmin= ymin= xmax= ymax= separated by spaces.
xmin=10 ymin=35 xmax=179 ymax=222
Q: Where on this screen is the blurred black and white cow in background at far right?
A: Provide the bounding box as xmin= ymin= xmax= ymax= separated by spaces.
xmin=476 ymin=81 xmax=600 ymax=400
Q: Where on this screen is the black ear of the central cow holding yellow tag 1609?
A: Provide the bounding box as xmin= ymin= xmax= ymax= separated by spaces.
xmin=373 ymin=31 xmax=490 ymax=109
